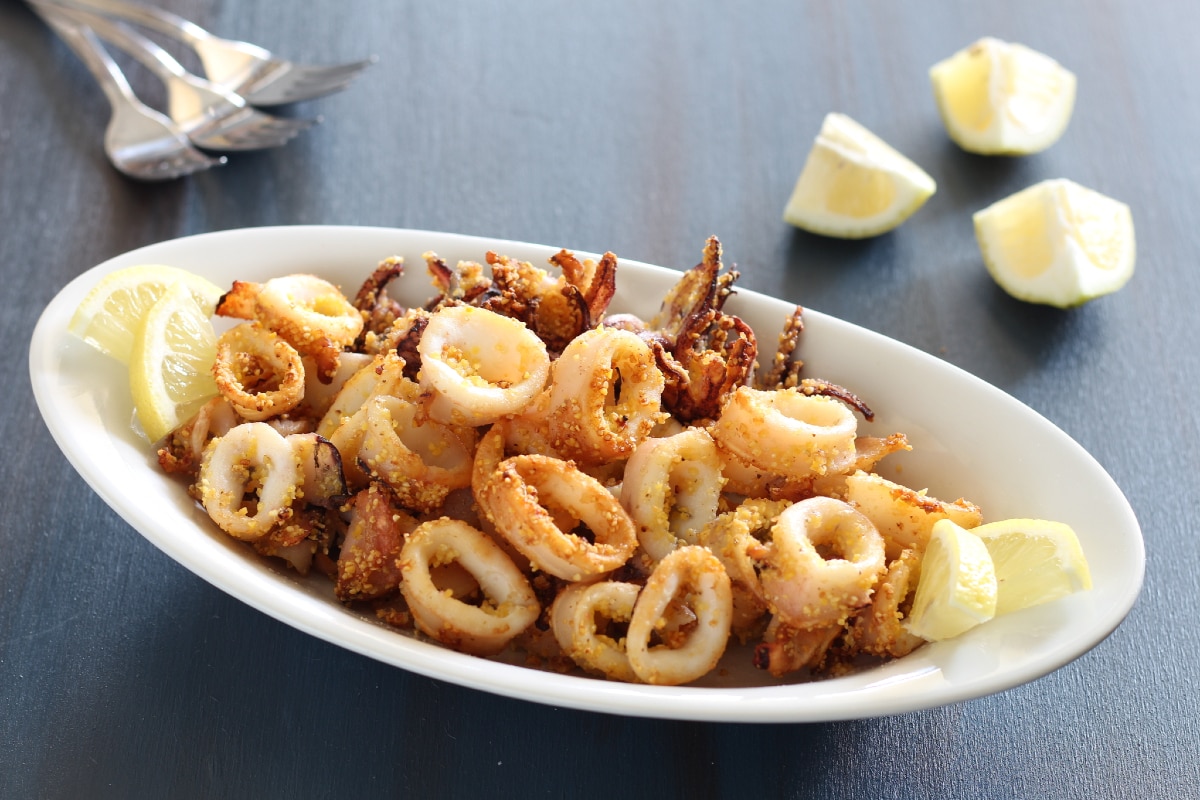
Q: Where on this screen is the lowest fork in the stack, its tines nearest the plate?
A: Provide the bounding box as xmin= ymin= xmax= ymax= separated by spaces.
xmin=30 ymin=4 xmax=226 ymax=181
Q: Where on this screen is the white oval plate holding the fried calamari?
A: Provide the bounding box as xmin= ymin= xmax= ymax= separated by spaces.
xmin=29 ymin=227 xmax=1145 ymax=722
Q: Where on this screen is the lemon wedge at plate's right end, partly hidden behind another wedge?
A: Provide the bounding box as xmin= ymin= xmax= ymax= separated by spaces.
xmin=971 ymin=519 xmax=1092 ymax=616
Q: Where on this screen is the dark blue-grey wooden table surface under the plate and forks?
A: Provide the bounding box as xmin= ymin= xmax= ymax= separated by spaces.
xmin=0 ymin=0 xmax=1200 ymax=798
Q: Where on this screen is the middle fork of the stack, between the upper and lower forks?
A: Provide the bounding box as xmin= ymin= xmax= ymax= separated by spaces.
xmin=36 ymin=0 xmax=316 ymax=150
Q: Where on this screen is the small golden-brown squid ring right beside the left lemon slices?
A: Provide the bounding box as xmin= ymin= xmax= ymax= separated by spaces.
xmin=212 ymin=323 xmax=304 ymax=422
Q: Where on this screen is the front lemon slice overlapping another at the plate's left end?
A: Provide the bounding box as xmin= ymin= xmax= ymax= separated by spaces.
xmin=130 ymin=283 xmax=217 ymax=441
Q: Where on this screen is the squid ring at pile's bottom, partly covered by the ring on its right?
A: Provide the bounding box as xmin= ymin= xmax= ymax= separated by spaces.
xmin=550 ymin=581 xmax=641 ymax=682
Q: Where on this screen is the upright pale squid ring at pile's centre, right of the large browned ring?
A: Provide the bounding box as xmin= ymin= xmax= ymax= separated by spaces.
xmin=620 ymin=428 xmax=724 ymax=561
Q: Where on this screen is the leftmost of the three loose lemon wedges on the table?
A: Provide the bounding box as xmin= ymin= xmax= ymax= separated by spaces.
xmin=784 ymin=114 xmax=937 ymax=239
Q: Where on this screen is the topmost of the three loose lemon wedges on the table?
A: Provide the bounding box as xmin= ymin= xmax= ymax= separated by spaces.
xmin=929 ymin=37 xmax=1075 ymax=156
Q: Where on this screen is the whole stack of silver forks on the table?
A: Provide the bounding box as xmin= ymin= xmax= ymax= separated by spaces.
xmin=28 ymin=0 xmax=374 ymax=180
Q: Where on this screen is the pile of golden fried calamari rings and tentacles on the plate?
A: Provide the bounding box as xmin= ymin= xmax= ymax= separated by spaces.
xmin=158 ymin=237 xmax=980 ymax=684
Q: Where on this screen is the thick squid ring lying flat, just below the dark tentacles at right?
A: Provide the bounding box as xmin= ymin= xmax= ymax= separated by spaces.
xmin=712 ymin=386 xmax=858 ymax=480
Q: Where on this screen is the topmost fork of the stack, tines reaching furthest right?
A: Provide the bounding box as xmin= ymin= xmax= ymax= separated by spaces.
xmin=43 ymin=0 xmax=376 ymax=106
